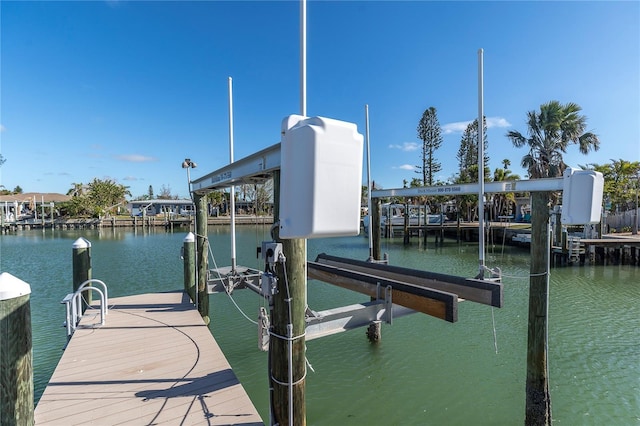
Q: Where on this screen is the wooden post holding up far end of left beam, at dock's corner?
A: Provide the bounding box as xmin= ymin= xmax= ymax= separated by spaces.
xmin=194 ymin=194 xmax=210 ymax=325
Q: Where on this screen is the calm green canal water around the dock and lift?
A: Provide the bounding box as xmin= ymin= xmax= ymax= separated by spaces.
xmin=0 ymin=226 xmax=640 ymax=425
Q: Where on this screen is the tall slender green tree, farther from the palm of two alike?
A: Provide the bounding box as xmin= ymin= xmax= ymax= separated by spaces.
xmin=416 ymin=107 xmax=442 ymax=186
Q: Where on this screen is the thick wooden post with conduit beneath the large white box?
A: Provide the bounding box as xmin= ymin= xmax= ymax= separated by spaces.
xmin=269 ymin=170 xmax=307 ymax=426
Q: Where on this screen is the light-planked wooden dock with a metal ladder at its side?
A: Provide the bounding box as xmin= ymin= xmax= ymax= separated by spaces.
xmin=35 ymin=291 xmax=264 ymax=426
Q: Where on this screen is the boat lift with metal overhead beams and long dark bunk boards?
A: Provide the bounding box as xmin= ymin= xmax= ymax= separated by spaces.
xmin=192 ymin=130 xmax=597 ymax=340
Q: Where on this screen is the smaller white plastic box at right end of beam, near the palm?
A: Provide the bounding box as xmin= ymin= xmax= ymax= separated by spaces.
xmin=561 ymin=167 xmax=604 ymax=225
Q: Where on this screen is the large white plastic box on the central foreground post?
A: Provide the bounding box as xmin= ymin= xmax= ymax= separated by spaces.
xmin=280 ymin=115 xmax=363 ymax=238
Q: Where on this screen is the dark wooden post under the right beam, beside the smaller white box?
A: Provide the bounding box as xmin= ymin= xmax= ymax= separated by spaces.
xmin=524 ymin=192 xmax=551 ymax=426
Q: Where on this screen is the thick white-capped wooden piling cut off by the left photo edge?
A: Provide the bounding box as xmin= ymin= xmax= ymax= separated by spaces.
xmin=0 ymin=272 xmax=34 ymax=426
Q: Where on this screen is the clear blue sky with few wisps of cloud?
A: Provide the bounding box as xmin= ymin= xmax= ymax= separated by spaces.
xmin=0 ymin=1 xmax=640 ymax=197
